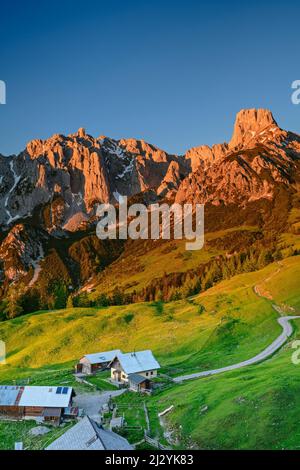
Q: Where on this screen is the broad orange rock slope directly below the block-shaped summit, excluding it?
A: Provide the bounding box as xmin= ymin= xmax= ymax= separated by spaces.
xmin=175 ymin=148 xmax=297 ymax=207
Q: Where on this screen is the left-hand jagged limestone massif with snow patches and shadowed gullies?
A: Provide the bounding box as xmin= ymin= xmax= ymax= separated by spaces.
xmin=0 ymin=129 xmax=187 ymax=230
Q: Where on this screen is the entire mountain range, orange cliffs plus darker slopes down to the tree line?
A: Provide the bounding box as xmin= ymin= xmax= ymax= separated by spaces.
xmin=0 ymin=109 xmax=300 ymax=314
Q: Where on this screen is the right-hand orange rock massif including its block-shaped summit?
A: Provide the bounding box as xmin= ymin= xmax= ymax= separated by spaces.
xmin=176 ymin=109 xmax=300 ymax=206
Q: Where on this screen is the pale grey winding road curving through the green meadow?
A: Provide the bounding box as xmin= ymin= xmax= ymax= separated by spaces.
xmin=173 ymin=267 xmax=300 ymax=383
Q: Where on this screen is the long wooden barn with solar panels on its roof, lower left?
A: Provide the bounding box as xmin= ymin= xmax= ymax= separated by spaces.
xmin=0 ymin=385 xmax=78 ymax=425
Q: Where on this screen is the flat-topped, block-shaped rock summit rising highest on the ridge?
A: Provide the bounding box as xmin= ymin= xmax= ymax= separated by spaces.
xmin=229 ymin=109 xmax=279 ymax=149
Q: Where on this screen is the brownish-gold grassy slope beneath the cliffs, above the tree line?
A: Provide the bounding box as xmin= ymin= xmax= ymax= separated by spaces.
xmin=86 ymin=225 xmax=260 ymax=299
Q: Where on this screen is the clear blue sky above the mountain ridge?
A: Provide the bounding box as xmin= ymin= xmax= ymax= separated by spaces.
xmin=0 ymin=0 xmax=300 ymax=155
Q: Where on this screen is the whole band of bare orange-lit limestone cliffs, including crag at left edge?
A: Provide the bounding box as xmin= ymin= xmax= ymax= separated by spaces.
xmin=0 ymin=109 xmax=300 ymax=283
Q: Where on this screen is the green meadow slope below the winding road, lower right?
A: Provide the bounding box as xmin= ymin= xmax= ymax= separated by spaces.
xmin=144 ymin=321 xmax=300 ymax=449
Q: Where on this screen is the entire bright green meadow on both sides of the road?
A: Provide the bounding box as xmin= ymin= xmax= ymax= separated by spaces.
xmin=0 ymin=256 xmax=300 ymax=449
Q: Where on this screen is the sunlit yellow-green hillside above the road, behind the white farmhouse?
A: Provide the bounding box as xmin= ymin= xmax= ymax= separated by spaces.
xmin=0 ymin=257 xmax=300 ymax=381
